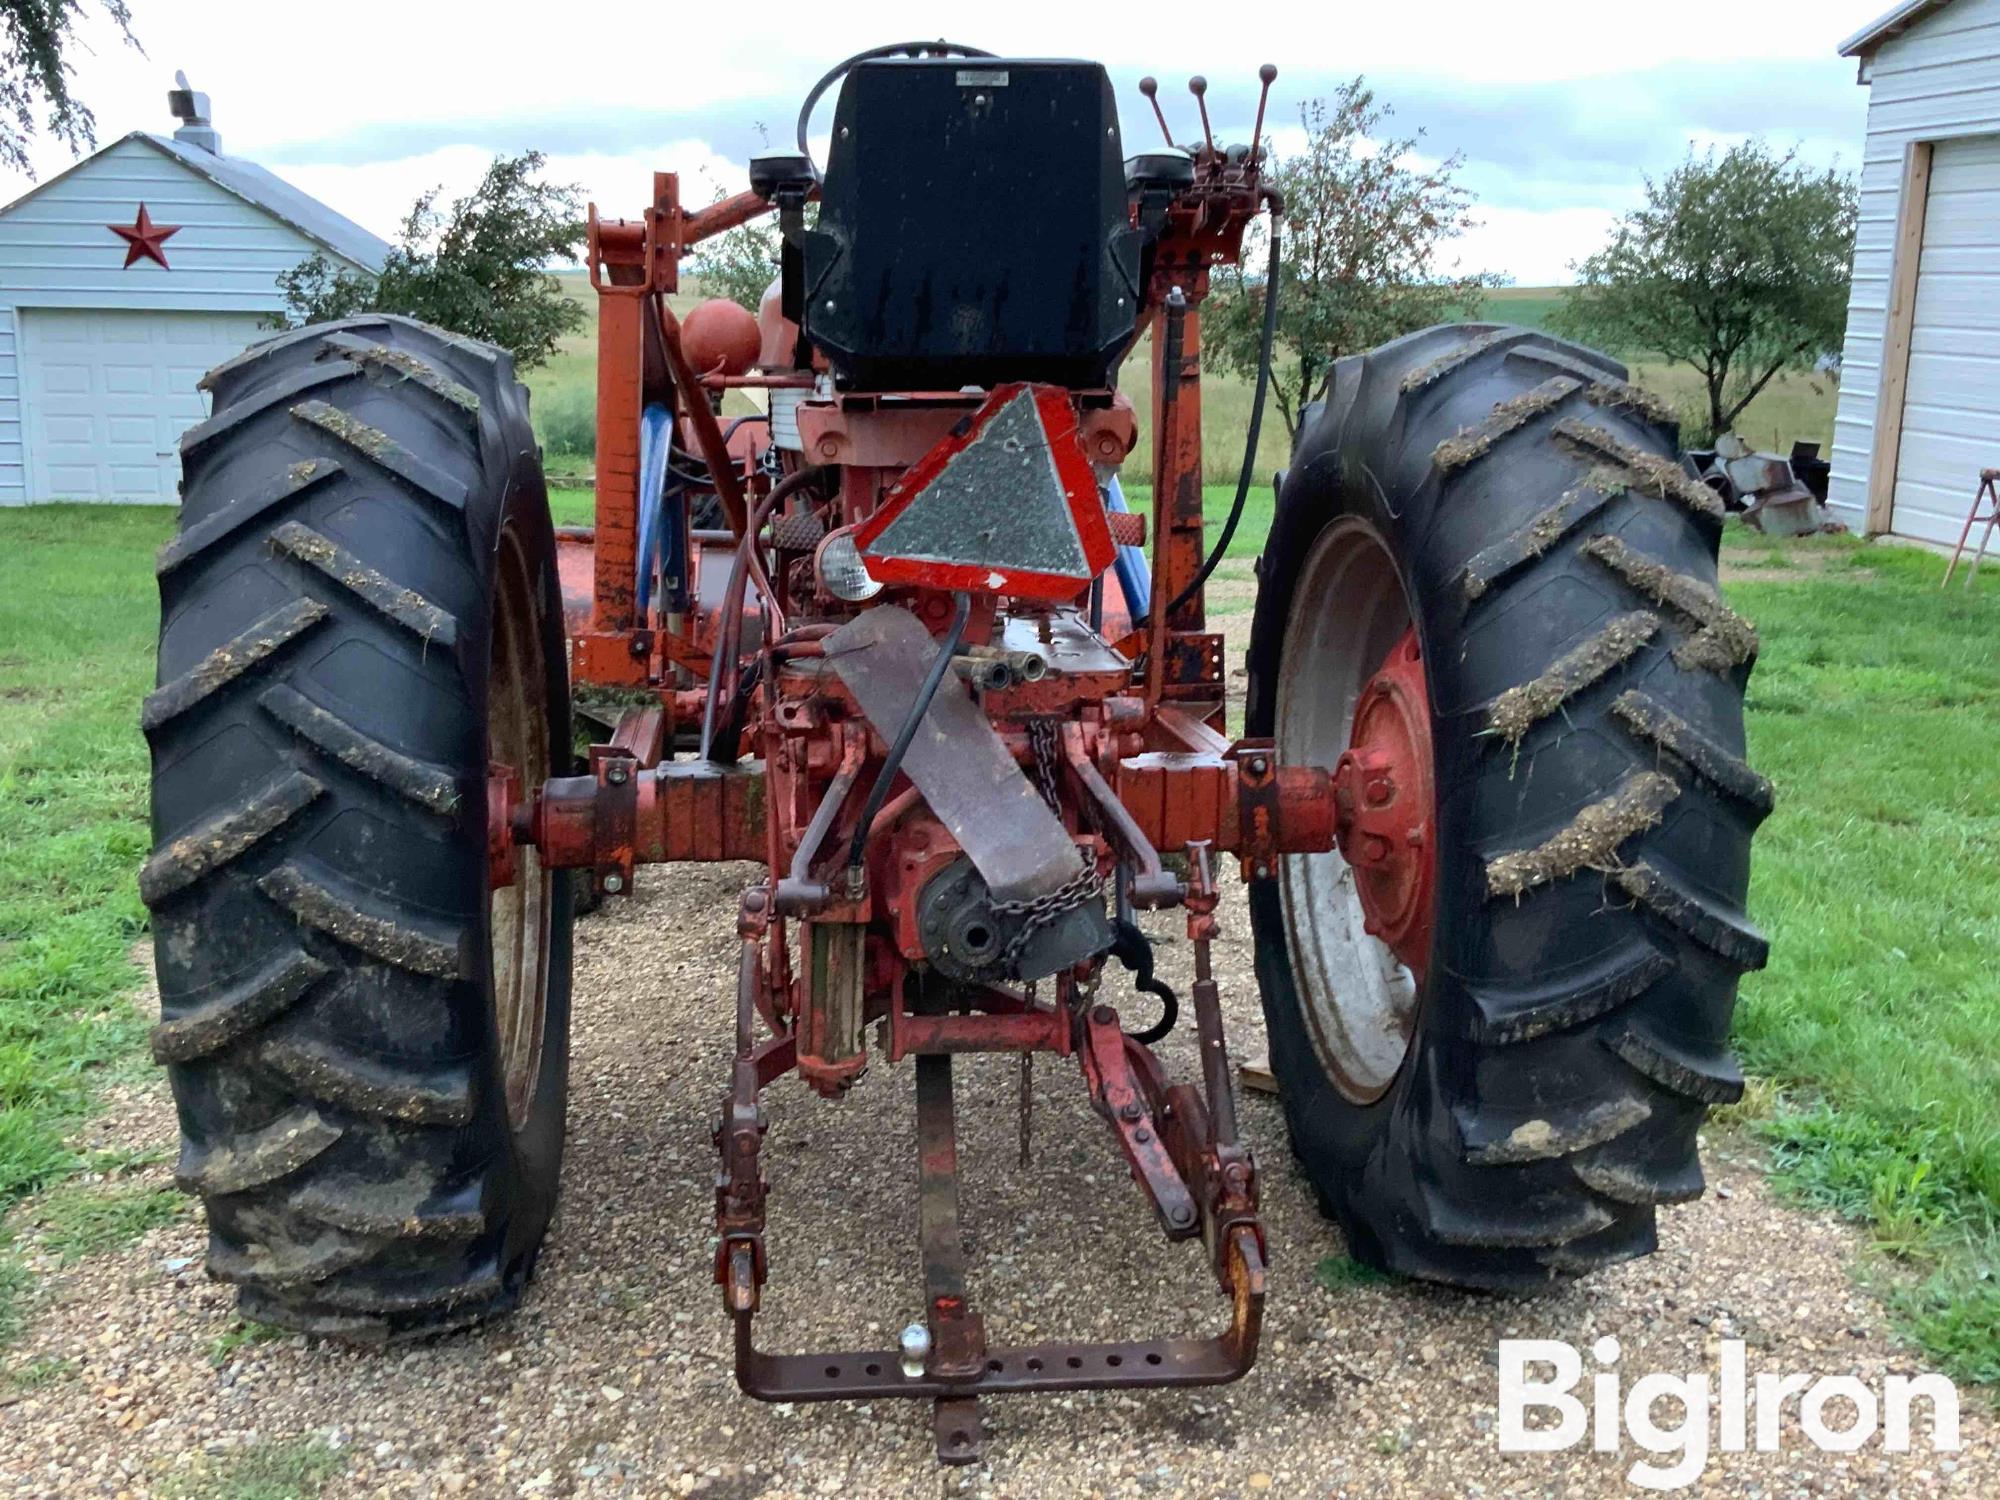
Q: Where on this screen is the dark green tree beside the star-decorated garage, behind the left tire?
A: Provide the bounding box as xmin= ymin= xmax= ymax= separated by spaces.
xmin=276 ymin=152 xmax=584 ymax=366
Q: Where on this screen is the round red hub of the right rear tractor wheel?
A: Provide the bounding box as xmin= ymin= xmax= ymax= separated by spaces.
xmin=1334 ymin=628 xmax=1438 ymax=980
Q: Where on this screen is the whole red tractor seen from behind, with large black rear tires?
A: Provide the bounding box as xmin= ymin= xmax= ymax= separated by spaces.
xmin=142 ymin=44 xmax=1770 ymax=1462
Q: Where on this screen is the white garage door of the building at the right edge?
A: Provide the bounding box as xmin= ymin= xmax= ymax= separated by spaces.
xmin=1892 ymin=136 xmax=2000 ymax=542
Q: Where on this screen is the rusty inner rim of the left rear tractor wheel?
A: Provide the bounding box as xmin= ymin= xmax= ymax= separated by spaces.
xmin=486 ymin=526 xmax=554 ymax=1130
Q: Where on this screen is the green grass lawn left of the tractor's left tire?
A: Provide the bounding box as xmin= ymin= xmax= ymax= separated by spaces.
xmin=0 ymin=506 xmax=172 ymax=1326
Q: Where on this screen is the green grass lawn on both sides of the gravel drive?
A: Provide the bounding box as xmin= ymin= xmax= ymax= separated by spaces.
xmin=0 ymin=500 xmax=2000 ymax=1382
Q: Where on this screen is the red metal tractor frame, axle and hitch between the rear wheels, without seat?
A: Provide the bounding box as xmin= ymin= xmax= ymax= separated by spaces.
xmin=524 ymin=70 xmax=1352 ymax=1460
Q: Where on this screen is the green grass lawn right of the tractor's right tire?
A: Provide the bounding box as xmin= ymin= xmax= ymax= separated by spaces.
xmin=1730 ymin=528 xmax=2000 ymax=1382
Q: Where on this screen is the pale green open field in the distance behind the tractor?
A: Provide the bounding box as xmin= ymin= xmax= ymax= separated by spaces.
xmin=526 ymin=272 xmax=1838 ymax=484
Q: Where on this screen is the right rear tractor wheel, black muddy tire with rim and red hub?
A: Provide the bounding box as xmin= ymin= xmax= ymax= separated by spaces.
xmin=1248 ymin=326 xmax=1772 ymax=1290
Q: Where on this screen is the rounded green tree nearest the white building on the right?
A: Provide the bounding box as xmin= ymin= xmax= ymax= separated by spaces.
xmin=1552 ymin=140 xmax=1858 ymax=442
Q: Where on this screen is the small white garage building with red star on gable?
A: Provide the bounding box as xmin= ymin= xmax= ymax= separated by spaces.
xmin=0 ymin=90 xmax=388 ymax=506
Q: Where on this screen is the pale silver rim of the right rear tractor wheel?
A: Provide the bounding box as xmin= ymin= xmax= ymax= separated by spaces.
xmin=1274 ymin=516 xmax=1436 ymax=1104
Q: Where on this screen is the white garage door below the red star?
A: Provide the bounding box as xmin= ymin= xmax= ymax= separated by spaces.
xmin=22 ymin=308 xmax=258 ymax=504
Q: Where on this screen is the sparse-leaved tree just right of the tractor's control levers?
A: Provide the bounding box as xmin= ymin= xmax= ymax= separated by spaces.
xmin=1202 ymin=78 xmax=1498 ymax=432
